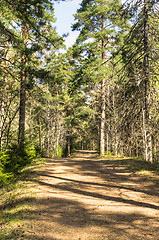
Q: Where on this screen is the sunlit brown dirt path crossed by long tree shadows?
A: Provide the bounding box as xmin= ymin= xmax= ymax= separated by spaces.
xmin=22 ymin=151 xmax=159 ymax=240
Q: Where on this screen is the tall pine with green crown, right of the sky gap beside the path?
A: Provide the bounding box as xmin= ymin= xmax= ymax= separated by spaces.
xmin=73 ymin=0 xmax=123 ymax=155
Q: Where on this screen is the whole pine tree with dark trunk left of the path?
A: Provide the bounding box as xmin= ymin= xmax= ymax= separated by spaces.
xmin=1 ymin=0 xmax=63 ymax=148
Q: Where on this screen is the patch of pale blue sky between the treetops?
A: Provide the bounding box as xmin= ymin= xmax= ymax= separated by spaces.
xmin=54 ymin=0 xmax=82 ymax=47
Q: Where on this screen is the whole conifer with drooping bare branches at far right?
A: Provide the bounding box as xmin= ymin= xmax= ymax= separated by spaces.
xmin=119 ymin=0 xmax=158 ymax=162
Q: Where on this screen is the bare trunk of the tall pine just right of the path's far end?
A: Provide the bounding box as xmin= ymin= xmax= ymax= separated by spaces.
xmin=100 ymin=16 xmax=106 ymax=155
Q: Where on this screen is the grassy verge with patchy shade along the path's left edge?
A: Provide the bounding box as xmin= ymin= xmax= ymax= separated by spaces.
xmin=0 ymin=159 xmax=44 ymax=240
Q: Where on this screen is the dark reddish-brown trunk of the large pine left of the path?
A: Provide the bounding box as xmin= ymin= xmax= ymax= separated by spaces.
xmin=18 ymin=25 xmax=27 ymax=150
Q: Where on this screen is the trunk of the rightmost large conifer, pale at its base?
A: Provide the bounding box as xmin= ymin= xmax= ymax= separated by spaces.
xmin=143 ymin=0 xmax=152 ymax=162
